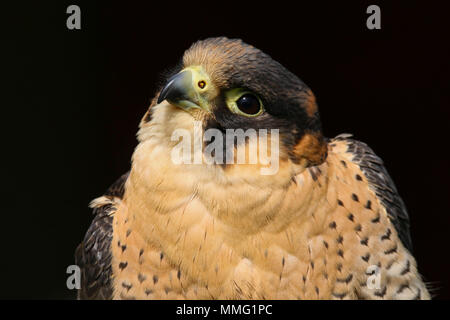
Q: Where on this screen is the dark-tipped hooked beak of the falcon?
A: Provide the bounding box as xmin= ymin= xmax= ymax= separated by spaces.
xmin=158 ymin=70 xmax=205 ymax=110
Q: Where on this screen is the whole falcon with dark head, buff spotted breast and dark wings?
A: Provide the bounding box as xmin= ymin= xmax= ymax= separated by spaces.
xmin=76 ymin=37 xmax=430 ymax=299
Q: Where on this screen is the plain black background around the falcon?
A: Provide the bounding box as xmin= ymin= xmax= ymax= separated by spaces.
xmin=6 ymin=0 xmax=450 ymax=299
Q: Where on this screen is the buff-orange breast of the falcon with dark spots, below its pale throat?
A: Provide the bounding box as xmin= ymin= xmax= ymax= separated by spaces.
xmin=108 ymin=141 xmax=429 ymax=299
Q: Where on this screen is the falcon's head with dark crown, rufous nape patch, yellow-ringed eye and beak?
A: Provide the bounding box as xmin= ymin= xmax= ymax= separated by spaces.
xmin=141 ymin=37 xmax=327 ymax=180
